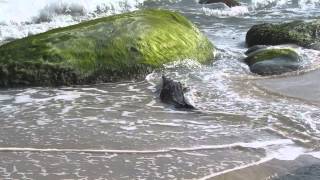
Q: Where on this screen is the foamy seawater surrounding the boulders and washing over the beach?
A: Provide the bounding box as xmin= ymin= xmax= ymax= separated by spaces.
xmin=0 ymin=0 xmax=320 ymax=180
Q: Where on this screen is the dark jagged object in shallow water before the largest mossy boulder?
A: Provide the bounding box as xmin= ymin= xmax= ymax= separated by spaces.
xmin=160 ymin=76 xmax=194 ymax=109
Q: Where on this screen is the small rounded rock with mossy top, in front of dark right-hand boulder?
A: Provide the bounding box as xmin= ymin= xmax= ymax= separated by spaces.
xmin=244 ymin=46 xmax=301 ymax=76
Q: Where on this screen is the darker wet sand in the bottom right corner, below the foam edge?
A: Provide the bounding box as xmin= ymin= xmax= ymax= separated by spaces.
xmin=211 ymin=155 xmax=320 ymax=180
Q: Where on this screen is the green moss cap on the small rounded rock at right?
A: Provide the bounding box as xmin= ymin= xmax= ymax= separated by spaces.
xmin=245 ymin=48 xmax=299 ymax=66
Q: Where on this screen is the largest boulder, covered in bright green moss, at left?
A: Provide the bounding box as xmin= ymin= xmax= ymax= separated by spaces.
xmin=0 ymin=9 xmax=214 ymax=87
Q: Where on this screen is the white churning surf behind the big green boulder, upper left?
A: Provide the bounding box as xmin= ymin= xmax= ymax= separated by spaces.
xmin=0 ymin=0 xmax=144 ymax=42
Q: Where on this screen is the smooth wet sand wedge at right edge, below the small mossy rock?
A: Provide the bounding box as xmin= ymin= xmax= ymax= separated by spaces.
xmin=255 ymin=70 xmax=320 ymax=105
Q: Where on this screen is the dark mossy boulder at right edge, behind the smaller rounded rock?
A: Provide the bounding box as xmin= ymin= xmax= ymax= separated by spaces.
xmin=246 ymin=20 xmax=320 ymax=50
